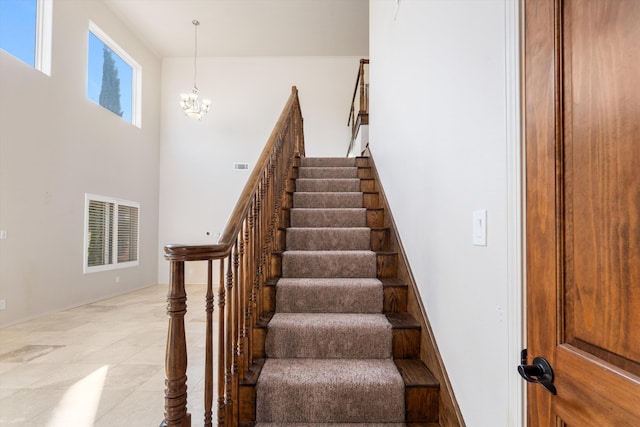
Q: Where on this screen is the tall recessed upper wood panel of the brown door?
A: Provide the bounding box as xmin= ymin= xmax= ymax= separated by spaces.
xmin=563 ymin=0 xmax=640 ymax=374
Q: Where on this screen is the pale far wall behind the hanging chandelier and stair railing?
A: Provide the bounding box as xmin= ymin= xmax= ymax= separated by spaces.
xmin=158 ymin=57 xmax=360 ymax=284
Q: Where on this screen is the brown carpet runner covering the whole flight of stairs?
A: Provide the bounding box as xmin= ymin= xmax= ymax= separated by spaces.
xmin=256 ymin=158 xmax=405 ymax=427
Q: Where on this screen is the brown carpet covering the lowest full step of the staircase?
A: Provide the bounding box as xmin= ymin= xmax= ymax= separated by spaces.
xmin=256 ymin=359 xmax=405 ymax=424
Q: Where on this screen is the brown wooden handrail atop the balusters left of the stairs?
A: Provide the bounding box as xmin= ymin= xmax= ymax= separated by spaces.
xmin=164 ymin=85 xmax=304 ymax=261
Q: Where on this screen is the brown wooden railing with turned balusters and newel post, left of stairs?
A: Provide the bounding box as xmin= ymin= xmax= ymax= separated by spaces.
xmin=160 ymin=86 xmax=304 ymax=427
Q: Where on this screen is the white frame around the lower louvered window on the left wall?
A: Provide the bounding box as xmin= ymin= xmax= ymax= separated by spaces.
xmin=82 ymin=193 xmax=140 ymax=274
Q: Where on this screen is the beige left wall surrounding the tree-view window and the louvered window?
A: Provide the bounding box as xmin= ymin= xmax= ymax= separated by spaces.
xmin=0 ymin=1 xmax=161 ymax=326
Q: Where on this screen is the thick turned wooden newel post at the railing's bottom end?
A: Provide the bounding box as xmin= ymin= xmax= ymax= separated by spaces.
xmin=160 ymin=260 xmax=191 ymax=427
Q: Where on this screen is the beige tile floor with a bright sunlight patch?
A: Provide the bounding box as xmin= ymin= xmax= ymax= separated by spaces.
xmin=0 ymin=285 xmax=215 ymax=427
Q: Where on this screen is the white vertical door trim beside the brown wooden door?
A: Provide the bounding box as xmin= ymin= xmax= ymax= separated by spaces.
xmin=504 ymin=0 xmax=526 ymax=426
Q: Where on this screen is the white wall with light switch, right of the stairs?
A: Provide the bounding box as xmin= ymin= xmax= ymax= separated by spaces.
xmin=370 ymin=0 xmax=522 ymax=427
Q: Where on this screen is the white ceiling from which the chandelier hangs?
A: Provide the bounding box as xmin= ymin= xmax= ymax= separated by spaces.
xmin=105 ymin=0 xmax=369 ymax=58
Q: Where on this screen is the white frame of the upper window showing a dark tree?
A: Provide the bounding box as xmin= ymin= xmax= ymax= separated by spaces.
xmin=85 ymin=20 xmax=142 ymax=128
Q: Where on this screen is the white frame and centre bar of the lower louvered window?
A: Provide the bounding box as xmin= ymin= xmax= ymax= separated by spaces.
xmin=82 ymin=193 xmax=140 ymax=274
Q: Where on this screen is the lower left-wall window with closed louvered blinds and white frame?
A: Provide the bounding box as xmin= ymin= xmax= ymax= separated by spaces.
xmin=84 ymin=194 xmax=140 ymax=273
